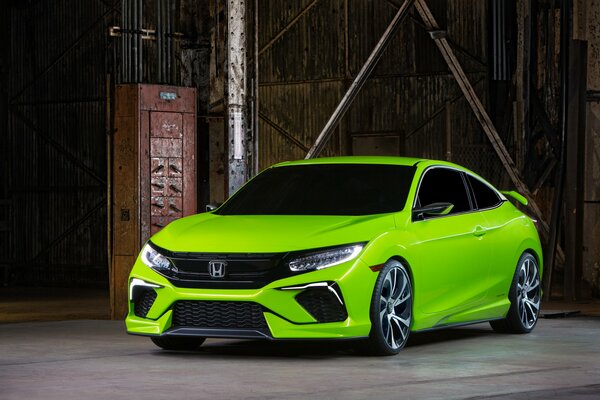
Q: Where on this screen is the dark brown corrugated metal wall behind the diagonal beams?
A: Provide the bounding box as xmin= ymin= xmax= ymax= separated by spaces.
xmin=259 ymin=0 xmax=504 ymax=183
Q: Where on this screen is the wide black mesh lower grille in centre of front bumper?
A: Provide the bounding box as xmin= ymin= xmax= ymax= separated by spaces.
xmin=173 ymin=300 xmax=269 ymax=334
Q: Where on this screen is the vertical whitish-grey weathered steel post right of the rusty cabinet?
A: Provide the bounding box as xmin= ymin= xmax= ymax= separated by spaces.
xmin=227 ymin=0 xmax=248 ymax=196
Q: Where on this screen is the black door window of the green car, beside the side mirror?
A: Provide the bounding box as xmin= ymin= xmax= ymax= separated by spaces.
xmin=417 ymin=168 xmax=471 ymax=214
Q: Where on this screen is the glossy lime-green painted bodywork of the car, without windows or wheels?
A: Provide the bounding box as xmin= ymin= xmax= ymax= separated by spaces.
xmin=126 ymin=157 xmax=542 ymax=339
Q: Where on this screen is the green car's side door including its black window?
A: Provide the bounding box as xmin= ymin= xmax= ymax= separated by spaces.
xmin=412 ymin=167 xmax=490 ymax=314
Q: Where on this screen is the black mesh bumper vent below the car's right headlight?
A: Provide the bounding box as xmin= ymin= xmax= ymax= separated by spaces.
xmin=296 ymin=288 xmax=348 ymax=322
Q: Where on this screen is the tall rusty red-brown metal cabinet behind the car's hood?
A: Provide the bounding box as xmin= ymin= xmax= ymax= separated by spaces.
xmin=111 ymin=84 xmax=197 ymax=318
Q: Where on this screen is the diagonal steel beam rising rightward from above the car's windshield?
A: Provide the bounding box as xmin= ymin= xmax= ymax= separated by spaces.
xmin=305 ymin=0 xmax=414 ymax=159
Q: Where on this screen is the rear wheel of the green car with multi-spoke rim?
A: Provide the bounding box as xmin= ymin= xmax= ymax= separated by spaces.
xmin=490 ymin=252 xmax=541 ymax=333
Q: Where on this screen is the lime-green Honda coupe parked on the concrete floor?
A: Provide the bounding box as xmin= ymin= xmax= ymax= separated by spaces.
xmin=126 ymin=157 xmax=542 ymax=355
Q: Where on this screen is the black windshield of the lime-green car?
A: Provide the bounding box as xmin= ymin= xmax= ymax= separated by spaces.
xmin=216 ymin=164 xmax=415 ymax=215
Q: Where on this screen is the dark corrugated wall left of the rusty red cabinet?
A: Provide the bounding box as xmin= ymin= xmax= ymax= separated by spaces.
xmin=9 ymin=0 xmax=116 ymax=286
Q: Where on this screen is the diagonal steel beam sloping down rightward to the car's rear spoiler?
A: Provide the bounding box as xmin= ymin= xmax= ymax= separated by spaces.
xmin=415 ymin=0 xmax=549 ymax=235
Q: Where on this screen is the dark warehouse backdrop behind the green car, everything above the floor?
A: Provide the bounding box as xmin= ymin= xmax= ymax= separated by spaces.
xmin=0 ymin=0 xmax=600 ymax=398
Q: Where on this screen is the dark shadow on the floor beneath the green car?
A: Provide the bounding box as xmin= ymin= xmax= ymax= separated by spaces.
xmin=148 ymin=327 xmax=494 ymax=359
